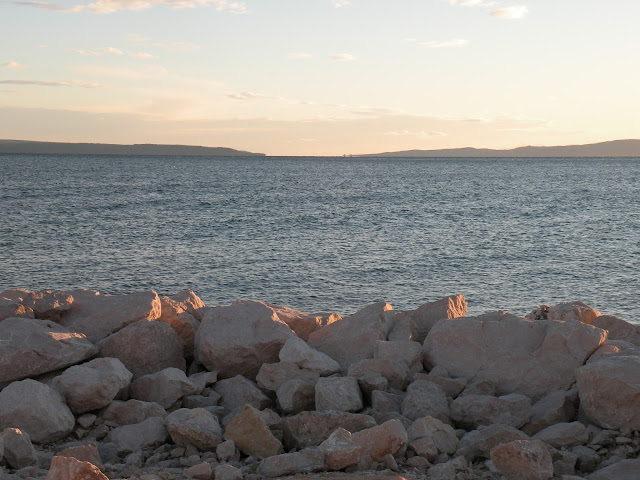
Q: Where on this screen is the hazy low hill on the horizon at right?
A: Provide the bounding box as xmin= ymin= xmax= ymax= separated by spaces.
xmin=354 ymin=140 xmax=640 ymax=158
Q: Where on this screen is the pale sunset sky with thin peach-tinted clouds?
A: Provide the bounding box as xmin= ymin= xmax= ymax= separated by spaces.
xmin=0 ymin=0 xmax=640 ymax=155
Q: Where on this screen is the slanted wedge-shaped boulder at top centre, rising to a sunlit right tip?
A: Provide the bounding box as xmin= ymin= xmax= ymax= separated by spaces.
xmin=309 ymin=302 xmax=396 ymax=369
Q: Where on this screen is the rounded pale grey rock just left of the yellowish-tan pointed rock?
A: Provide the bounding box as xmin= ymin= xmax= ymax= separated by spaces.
xmin=166 ymin=408 xmax=222 ymax=451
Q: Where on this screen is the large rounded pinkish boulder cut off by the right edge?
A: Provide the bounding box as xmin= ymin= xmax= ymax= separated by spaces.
xmin=576 ymin=356 xmax=640 ymax=430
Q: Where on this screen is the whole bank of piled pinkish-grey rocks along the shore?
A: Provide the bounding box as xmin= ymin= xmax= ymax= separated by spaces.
xmin=0 ymin=290 xmax=640 ymax=480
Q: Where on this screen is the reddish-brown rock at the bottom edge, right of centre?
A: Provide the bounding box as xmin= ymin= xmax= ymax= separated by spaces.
xmin=491 ymin=440 xmax=553 ymax=480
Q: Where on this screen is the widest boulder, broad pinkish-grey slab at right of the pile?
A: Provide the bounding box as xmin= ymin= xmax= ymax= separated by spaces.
xmin=424 ymin=317 xmax=606 ymax=400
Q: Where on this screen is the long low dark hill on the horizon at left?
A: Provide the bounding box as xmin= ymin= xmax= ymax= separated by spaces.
xmin=0 ymin=140 xmax=264 ymax=157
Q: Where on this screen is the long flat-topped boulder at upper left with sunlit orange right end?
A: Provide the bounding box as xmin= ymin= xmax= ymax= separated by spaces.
xmin=61 ymin=290 xmax=161 ymax=342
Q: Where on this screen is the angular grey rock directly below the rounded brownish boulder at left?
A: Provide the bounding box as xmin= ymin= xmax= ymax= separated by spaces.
xmin=130 ymin=368 xmax=196 ymax=408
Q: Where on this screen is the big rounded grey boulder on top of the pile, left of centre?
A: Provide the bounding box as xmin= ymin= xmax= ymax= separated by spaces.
xmin=195 ymin=300 xmax=295 ymax=379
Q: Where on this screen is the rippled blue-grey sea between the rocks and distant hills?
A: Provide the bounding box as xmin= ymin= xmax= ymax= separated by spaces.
xmin=0 ymin=155 xmax=640 ymax=322
